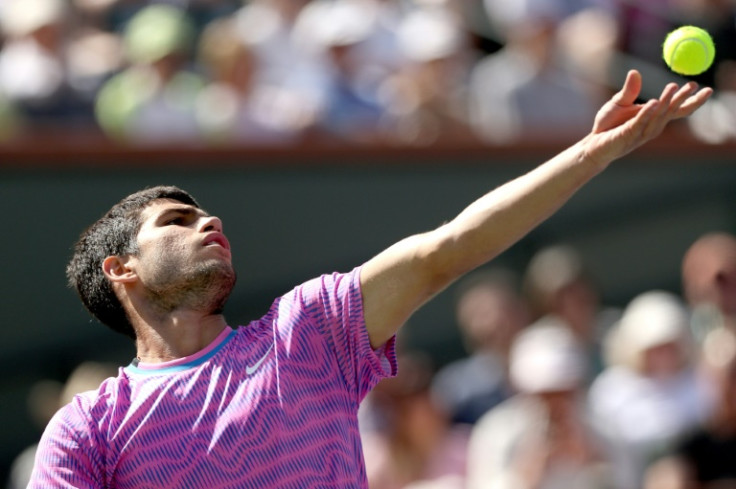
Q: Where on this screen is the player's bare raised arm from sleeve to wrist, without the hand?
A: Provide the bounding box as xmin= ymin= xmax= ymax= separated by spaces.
xmin=361 ymin=139 xmax=602 ymax=346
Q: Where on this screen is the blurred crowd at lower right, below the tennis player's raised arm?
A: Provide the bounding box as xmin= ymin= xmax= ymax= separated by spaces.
xmin=361 ymin=232 xmax=736 ymax=489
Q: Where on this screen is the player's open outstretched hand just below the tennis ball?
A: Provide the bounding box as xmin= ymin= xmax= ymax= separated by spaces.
xmin=586 ymin=70 xmax=713 ymax=165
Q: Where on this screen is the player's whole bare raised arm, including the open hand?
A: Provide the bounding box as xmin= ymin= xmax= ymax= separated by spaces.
xmin=360 ymin=71 xmax=712 ymax=347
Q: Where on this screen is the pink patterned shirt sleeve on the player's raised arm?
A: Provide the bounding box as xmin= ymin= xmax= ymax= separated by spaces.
xmin=299 ymin=267 xmax=396 ymax=401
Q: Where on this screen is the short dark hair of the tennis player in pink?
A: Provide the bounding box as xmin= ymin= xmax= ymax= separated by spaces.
xmin=66 ymin=186 xmax=199 ymax=339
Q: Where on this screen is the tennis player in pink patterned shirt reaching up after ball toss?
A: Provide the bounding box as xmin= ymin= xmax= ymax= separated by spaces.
xmin=29 ymin=71 xmax=712 ymax=489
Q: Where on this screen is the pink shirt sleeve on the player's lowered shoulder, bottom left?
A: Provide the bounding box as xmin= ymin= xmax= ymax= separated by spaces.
xmin=28 ymin=399 xmax=104 ymax=489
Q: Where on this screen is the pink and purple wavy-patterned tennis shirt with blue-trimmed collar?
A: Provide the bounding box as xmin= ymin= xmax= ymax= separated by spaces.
xmin=29 ymin=268 xmax=396 ymax=489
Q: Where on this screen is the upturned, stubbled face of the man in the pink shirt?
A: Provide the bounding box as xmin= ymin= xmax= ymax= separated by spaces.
xmin=126 ymin=199 xmax=235 ymax=313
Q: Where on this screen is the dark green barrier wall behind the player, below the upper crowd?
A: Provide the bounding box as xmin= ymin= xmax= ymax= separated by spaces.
xmin=0 ymin=139 xmax=736 ymax=484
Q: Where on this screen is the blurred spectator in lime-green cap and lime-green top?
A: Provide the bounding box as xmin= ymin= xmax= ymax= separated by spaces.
xmin=96 ymin=4 xmax=204 ymax=144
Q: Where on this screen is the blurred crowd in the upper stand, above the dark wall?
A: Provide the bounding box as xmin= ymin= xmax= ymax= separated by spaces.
xmin=0 ymin=0 xmax=736 ymax=145
